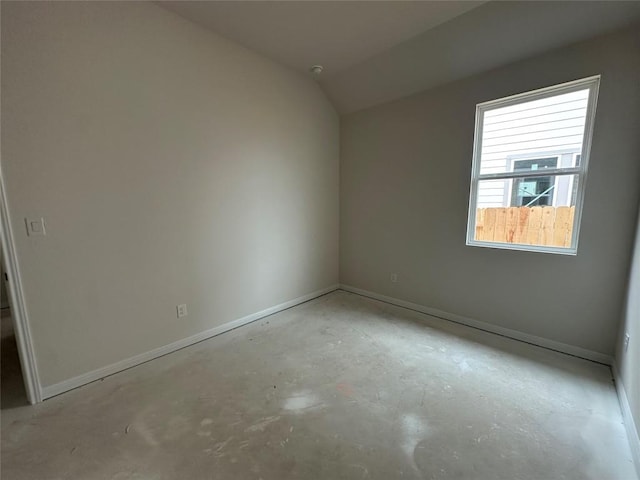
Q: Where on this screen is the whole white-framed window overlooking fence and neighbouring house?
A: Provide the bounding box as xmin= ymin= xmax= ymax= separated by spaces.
xmin=467 ymin=76 xmax=600 ymax=254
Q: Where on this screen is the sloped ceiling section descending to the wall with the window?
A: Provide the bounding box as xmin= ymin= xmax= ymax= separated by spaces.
xmin=321 ymin=1 xmax=640 ymax=113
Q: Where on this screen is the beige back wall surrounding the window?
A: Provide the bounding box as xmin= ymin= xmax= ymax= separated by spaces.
xmin=340 ymin=26 xmax=640 ymax=355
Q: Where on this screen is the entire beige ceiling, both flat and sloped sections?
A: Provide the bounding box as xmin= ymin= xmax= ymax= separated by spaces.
xmin=158 ymin=0 xmax=640 ymax=113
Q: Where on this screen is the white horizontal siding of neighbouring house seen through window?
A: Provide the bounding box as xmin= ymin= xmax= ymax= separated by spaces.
xmin=477 ymin=90 xmax=588 ymax=208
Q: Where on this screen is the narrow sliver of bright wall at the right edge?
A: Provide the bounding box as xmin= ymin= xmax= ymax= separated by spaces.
xmin=616 ymin=205 xmax=640 ymax=462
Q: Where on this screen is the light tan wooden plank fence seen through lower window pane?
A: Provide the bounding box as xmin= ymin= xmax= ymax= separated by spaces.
xmin=475 ymin=207 xmax=575 ymax=247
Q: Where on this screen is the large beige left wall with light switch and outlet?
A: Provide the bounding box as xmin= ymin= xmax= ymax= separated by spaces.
xmin=2 ymin=2 xmax=339 ymax=386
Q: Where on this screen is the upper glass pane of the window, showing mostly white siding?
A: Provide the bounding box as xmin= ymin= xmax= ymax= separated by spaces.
xmin=480 ymin=89 xmax=589 ymax=175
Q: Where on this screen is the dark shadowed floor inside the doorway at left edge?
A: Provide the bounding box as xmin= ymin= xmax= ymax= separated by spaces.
xmin=0 ymin=311 xmax=29 ymax=410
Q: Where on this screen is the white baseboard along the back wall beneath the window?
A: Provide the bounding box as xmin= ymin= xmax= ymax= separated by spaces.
xmin=340 ymin=284 xmax=613 ymax=365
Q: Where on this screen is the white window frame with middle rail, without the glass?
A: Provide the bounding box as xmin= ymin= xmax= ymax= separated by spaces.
xmin=467 ymin=75 xmax=600 ymax=255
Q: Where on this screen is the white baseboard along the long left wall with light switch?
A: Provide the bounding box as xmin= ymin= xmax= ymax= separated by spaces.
xmin=42 ymin=285 xmax=339 ymax=399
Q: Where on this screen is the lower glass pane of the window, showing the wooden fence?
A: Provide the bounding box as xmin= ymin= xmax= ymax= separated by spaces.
xmin=474 ymin=175 xmax=578 ymax=248
